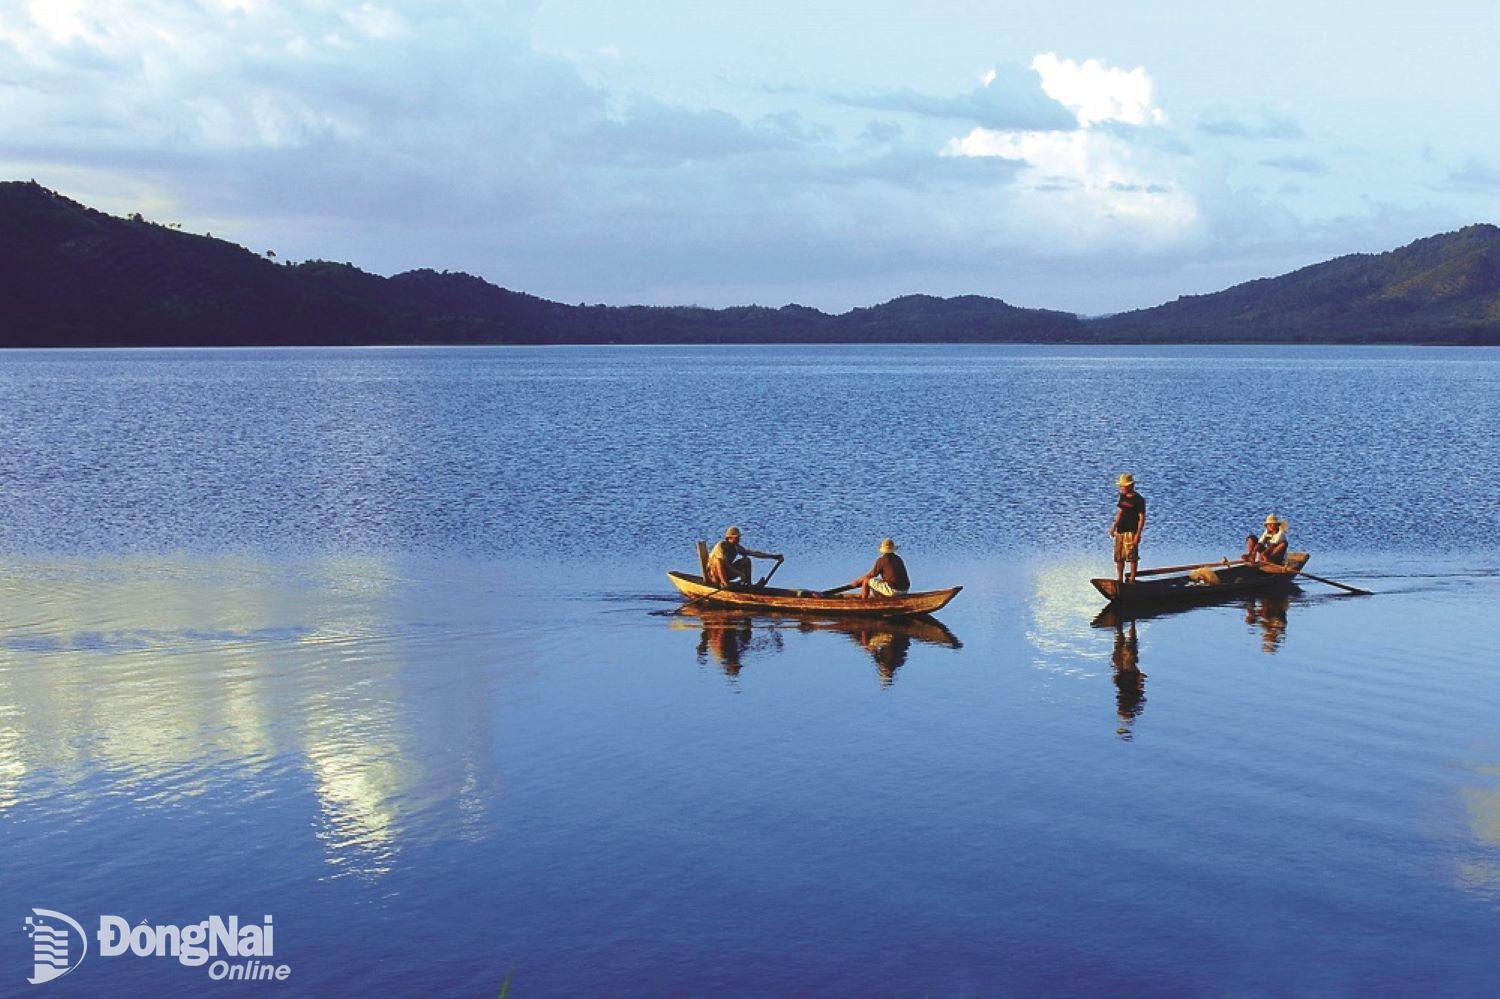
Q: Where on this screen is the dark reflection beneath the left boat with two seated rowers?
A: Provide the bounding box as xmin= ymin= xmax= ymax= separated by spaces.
xmin=672 ymin=608 xmax=963 ymax=687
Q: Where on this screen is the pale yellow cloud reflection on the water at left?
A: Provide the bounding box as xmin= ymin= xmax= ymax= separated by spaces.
xmin=0 ymin=557 xmax=497 ymax=876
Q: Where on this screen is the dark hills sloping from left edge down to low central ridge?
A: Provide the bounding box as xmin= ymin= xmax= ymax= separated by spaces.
xmin=0 ymin=182 xmax=1083 ymax=347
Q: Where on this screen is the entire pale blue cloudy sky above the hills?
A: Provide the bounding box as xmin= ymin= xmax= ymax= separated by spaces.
xmin=0 ymin=0 xmax=1500 ymax=314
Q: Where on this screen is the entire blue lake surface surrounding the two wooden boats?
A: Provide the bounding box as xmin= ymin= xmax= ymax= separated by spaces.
xmin=0 ymin=347 xmax=1500 ymax=996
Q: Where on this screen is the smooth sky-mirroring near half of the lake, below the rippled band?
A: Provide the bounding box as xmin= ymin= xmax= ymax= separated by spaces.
xmin=0 ymin=557 xmax=1500 ymax=995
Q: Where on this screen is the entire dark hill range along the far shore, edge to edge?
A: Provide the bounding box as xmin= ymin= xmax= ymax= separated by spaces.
xmin=0 ymin=182 xmax=1500 ymax=347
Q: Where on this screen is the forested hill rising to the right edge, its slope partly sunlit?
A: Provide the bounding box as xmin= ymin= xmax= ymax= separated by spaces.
xmin=1089 ymin=225 xmax=1500 ymax=345
